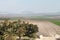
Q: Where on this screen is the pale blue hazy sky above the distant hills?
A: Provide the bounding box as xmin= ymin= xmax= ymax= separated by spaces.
xmin=0 ymin=0 xmax=60 ymax=13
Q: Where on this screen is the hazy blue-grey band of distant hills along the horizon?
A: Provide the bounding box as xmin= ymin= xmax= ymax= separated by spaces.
xmin=0 ymin=12 xmax=60 ymax=17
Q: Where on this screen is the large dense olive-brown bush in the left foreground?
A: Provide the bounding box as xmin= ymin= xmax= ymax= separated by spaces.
xmin=0 ymin=19 xmax=38 ymax=40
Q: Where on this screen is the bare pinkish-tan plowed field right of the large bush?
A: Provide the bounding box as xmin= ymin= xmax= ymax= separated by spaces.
xmin=29 ymin=20 xmax=60 ymax=36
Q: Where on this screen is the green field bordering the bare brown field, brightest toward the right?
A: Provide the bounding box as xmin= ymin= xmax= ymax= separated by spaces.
xmin=31 ymin=16 xmax=60 ymax=26
